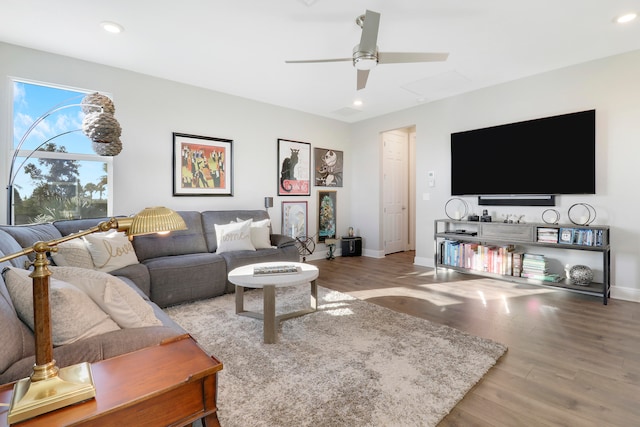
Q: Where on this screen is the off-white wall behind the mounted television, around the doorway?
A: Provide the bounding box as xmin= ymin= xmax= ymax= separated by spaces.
xmin=351 ymin=51 xmax=640 ymax=301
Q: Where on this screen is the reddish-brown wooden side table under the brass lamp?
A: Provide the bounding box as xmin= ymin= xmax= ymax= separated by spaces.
xmin=0 ymin=335 xmax=222 ymax=427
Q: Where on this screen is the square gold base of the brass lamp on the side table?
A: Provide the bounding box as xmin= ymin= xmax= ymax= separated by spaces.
xmin=7 ymin=362 xmax=96 ymax=424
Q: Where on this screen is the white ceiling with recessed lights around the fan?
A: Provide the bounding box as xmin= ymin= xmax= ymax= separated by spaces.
xmin=0 ymin=0 xmax=640 ymax=122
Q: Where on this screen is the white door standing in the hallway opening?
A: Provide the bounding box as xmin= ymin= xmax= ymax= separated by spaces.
xmin=382 ymin=131 xmax=409 ymax=255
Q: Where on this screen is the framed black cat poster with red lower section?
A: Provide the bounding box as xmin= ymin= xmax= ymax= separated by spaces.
xmin=278 ymin=139 xmax=311 ymax=196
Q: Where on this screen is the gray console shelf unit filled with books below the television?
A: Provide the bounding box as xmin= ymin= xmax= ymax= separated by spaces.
xmin=434 ymin=219 xmax=611 ymax=304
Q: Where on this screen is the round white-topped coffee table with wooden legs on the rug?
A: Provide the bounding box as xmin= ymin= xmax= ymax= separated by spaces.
xmin=229 ymin=261 xmax=318 ymax=344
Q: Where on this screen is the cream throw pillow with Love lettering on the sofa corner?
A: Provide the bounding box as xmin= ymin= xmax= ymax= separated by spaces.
xmin=84 ymin=230 xmax=139 ymax=273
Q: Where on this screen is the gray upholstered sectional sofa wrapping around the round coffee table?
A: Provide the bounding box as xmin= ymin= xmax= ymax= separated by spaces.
xmin=0 ymin=210 xmax=299 ymax=384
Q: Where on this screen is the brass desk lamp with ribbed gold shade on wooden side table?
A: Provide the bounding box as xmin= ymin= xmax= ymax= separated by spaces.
xmin=0 ymin=207 xmax=187 ymax=424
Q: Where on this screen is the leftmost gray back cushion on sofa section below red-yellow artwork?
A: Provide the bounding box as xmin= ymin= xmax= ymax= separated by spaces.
xmin=133 ymin=211 xmax=208 ymax=262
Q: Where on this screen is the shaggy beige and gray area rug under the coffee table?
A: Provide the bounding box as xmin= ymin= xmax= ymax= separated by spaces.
xmin=165 ymin=286 xmax=506 ymax=427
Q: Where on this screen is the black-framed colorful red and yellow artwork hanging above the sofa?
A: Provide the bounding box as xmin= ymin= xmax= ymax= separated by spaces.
xmin=173 ymin=132 xmax=233 ymax=196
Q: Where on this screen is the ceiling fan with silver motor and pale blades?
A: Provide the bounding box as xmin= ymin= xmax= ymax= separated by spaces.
xmin=285 ymin=10 xmax=449 ymax=90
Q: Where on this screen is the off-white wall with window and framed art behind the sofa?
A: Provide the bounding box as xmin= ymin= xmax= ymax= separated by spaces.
xmin=0 ymin=43 xmax=352 ymax=256
